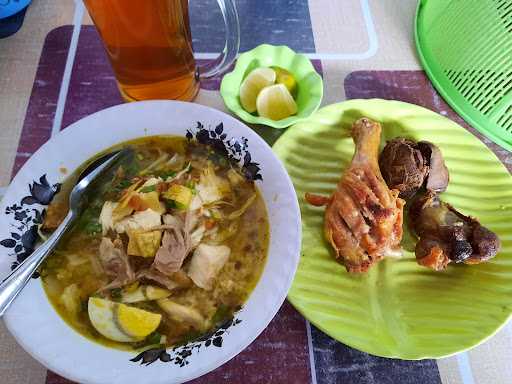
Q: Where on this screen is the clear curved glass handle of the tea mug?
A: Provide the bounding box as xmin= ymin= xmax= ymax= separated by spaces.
xmin=199 ymin=0 xmax=240 ymax=79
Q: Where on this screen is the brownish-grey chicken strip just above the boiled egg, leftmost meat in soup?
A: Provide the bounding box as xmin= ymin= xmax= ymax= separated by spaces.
xmin=99 ymin=237 xmax=135 ymax=290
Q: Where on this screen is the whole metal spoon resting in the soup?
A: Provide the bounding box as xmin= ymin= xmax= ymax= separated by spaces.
xmin=0 ymin=149 xmax=130 ymax=317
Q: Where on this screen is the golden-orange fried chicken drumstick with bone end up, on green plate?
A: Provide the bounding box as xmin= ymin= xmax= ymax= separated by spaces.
xmin=306 ymin=118 xmax=404 ymax=272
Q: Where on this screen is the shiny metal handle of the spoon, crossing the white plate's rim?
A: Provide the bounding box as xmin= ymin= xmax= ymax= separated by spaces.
xmin=0 ymin=211 xmax=75 ymax=317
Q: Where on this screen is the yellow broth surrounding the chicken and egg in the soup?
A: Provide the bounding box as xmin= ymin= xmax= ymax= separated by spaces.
xmin=40 ymin=136 xmax=269 ymax=350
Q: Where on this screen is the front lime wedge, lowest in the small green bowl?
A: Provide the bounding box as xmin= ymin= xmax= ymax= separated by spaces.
xmin=256 ymin=84 xmax=297 ymax=120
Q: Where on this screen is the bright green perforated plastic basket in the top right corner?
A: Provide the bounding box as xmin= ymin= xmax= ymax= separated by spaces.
xmin=415 ymin=0 xmax=512 ymax=151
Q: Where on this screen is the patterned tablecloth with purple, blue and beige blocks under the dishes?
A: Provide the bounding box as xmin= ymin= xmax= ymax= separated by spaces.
xmin=0 ymin=0 xmax=512 ymax=384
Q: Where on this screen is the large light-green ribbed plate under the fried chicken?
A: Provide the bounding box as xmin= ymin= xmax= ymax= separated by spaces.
xmin=274 ymin=99 xmax=512 ymax=360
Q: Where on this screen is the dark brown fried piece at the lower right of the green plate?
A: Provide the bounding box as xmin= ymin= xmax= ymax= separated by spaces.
xmin=409 ymin=191 xmax=500 ymax=271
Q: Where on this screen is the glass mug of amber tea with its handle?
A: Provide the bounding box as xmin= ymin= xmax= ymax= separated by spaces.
xmin=84 ymin=0 xmax=240 ymax=101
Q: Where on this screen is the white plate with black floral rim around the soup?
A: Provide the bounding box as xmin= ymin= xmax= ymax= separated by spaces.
xmin=0 ymin=101 xmax=301 ymax=384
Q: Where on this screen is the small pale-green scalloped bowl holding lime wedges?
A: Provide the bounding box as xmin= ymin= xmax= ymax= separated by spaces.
xmin=220 ymin=44 xmax=324 ymax=128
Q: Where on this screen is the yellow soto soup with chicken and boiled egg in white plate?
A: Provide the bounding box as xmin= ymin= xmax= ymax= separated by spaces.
xmin=40 ymin=136 xmax=269 ymax=350
